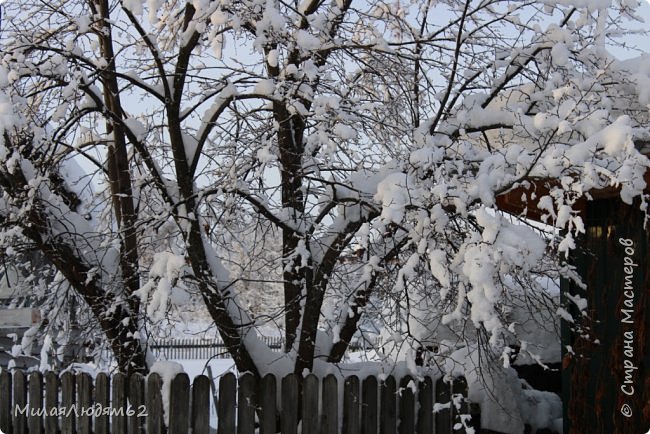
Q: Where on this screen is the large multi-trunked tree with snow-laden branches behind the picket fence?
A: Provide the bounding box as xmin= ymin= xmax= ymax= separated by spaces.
xmin=0 ymin=0 xmax=650 ymax=390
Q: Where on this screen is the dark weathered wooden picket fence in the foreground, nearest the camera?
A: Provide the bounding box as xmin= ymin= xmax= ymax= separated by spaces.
xmin=0 ymin=371 xmax=480 ymax=434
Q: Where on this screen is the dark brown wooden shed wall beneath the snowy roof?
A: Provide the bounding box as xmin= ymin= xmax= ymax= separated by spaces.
xmin=561 ymin=200 xmax=650 ymax=434
